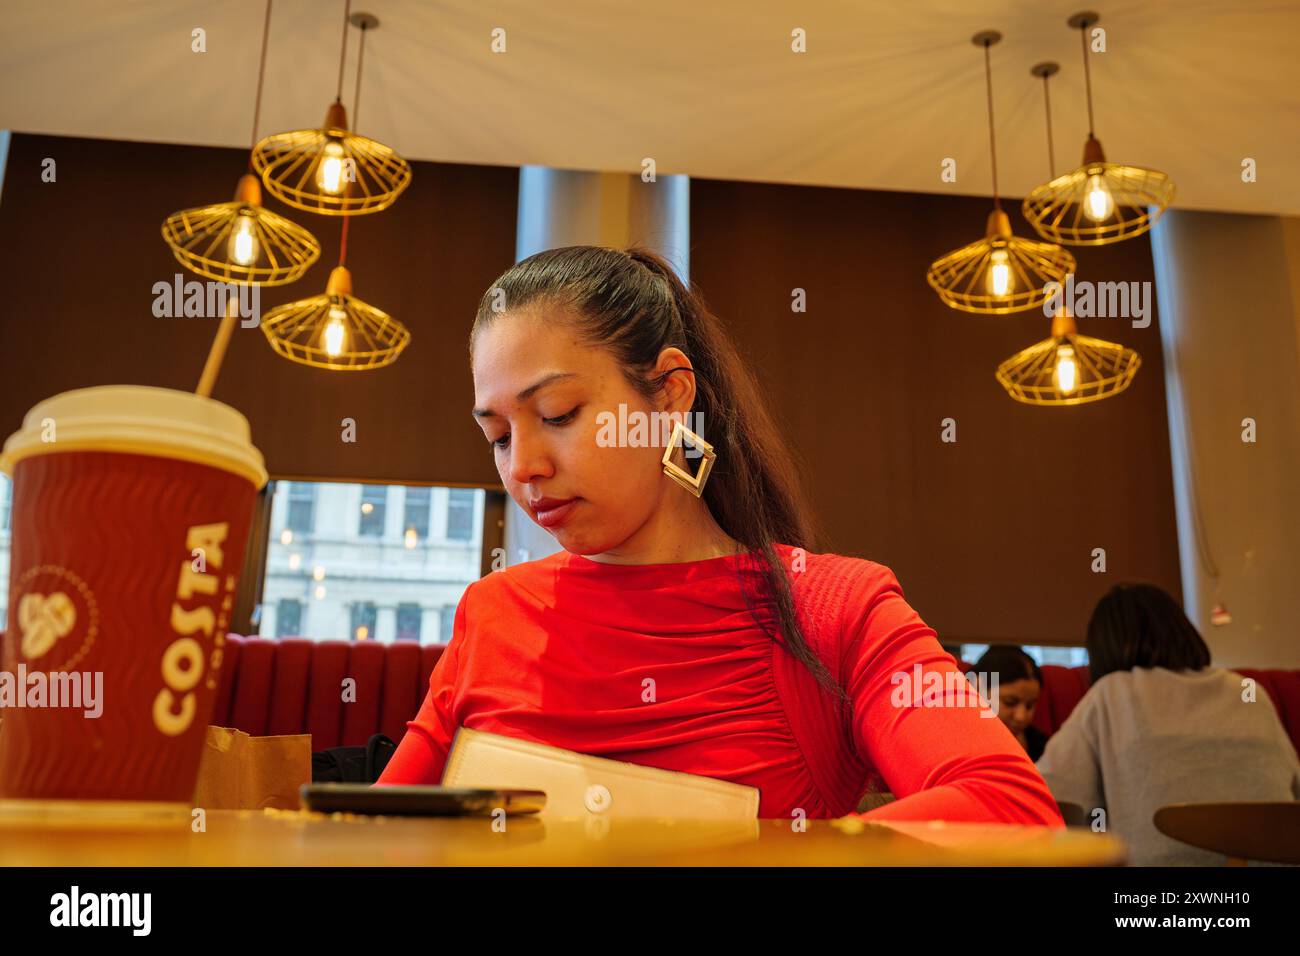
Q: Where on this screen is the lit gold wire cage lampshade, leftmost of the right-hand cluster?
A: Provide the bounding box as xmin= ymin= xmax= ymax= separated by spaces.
xmin=926 ymin=209 xmax=1075 ymax=315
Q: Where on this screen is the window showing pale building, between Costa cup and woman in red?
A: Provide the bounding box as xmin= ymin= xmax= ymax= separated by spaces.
xmin=257 ymin=481 xmax=488 ymax=644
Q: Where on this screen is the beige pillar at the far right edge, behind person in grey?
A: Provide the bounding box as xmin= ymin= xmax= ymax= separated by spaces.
xmin=1151 ymin=209 xmax=1300 ymax=667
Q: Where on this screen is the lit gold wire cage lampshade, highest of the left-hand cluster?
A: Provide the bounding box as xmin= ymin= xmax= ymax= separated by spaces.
xmin=252 ymin=101 xmax=411 ymax=216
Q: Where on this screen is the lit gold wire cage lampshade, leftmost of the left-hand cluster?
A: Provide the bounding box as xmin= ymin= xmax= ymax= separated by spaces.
xmin=163 ymin=173 xmax=321 ymax=285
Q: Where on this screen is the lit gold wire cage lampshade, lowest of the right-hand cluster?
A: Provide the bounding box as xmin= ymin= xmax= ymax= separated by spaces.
xmin=996 ymin=310 xmax=1141 ymax=405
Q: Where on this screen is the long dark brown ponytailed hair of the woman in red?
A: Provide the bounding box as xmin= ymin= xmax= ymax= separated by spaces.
xmin=469 ymin=246 xmax=848 ymax=702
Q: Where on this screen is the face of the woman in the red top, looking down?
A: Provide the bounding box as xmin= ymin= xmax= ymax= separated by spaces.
xmin=473 ymin=306 xmax=694 ymax=554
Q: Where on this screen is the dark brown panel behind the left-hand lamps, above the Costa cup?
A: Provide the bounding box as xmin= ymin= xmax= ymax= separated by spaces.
xmin=0 ymin=134 xmax=519 ymax=486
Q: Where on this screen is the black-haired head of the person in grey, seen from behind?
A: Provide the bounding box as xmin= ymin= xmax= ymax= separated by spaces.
xmin=1087 ymin=584 xmax=1210 ymax=683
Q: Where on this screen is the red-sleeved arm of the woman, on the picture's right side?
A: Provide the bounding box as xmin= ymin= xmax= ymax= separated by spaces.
xmin=842 ymin=564 xmax=1065 ymax=827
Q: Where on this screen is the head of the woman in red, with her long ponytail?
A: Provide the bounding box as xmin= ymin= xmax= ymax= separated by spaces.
xmin=469 ymin=246 xmax=828 ymax=697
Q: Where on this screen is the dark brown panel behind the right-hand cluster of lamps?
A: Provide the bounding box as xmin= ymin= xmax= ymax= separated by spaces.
xmin=690 ymin=179 xmax=1180 ymax=643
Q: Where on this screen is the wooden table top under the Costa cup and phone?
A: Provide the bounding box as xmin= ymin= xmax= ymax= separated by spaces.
xmin=0 ymin=810 xmax=1125 ymax=866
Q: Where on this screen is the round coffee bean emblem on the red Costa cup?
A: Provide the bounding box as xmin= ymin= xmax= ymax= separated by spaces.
xmin=13 ymin=564 xmax=99 ymax=672
